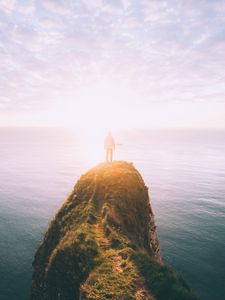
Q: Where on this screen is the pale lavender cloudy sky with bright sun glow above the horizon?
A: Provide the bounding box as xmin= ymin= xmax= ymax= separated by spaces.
xmin=0 ymin=0 xmax=225 ymax=130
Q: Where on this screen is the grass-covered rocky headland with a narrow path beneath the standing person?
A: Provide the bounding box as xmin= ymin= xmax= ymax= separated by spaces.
xmin=31 ymin=162 xmax=198 ymax=300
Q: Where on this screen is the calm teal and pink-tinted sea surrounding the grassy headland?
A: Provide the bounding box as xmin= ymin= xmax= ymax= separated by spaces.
xmin=0 ymin=128 xmax=225 ymax=300
